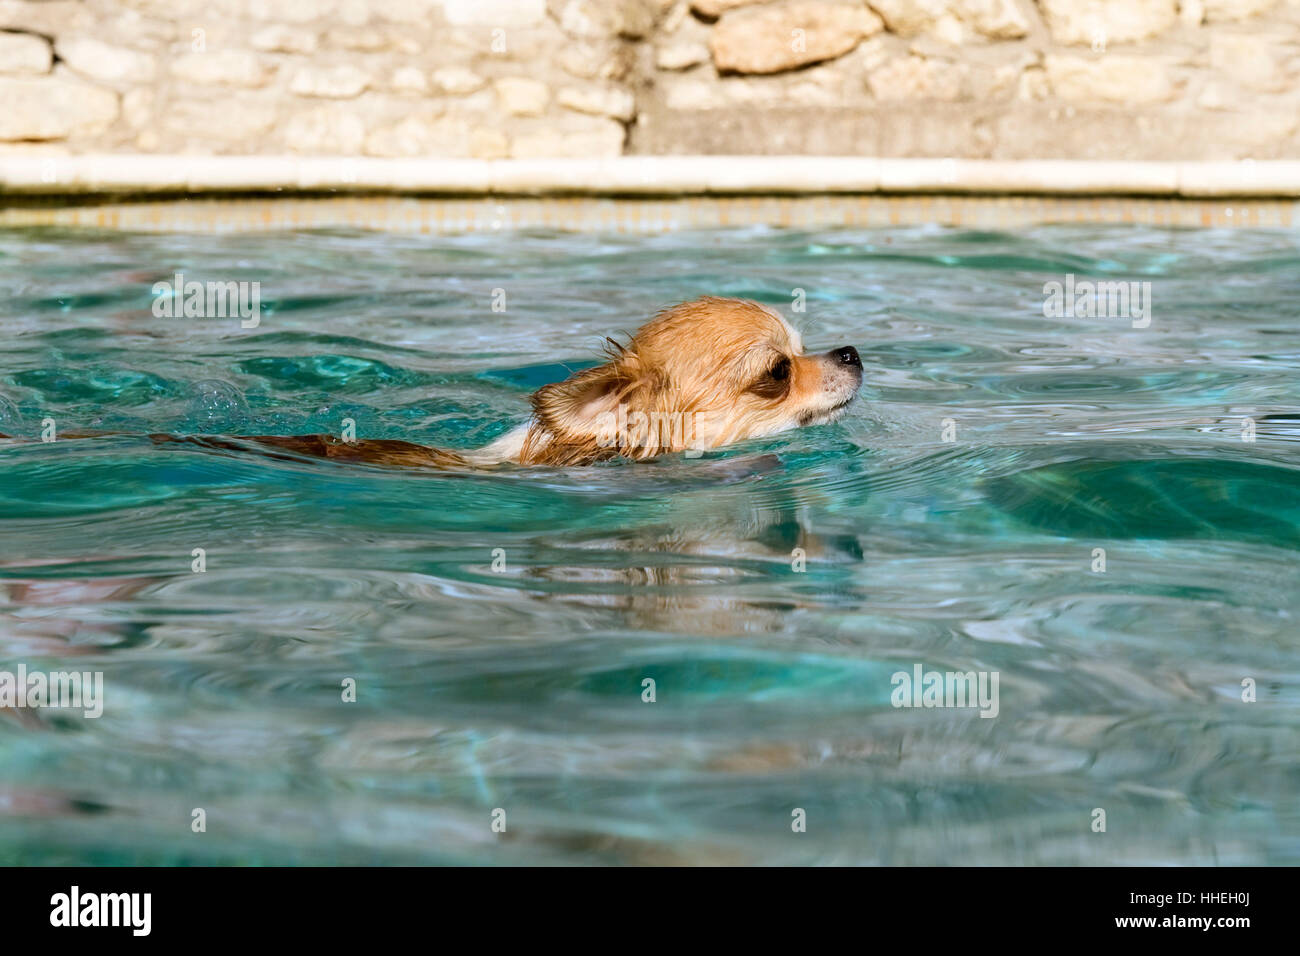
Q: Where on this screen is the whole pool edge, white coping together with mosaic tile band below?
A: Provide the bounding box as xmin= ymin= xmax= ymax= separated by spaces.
xmin=0 ymin=155 xmax=1300 ymax=233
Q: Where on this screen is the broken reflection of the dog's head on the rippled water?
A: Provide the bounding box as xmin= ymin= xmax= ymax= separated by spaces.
xmin=493 ymin=455 xmax=863 ymax=637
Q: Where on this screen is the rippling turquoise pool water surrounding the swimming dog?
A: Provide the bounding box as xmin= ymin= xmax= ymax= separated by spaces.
xmin=0 ymin=228 xmax=1300 ymax=865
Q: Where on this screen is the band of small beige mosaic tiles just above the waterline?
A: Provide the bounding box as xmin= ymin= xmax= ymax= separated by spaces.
xmin=0 ymin=195 xmax=1300 ymax=234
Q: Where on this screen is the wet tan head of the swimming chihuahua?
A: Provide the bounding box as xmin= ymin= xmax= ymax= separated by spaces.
xmin=523 ymin=297 xmax=862 ymax=464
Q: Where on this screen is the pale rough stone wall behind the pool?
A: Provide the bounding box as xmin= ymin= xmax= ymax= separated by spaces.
xmin=0 ymin=0 xmax=1300 ymax=159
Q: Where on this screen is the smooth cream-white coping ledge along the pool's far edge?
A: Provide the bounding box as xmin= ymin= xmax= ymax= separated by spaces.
xmin=0 ymin=153 xmax=1300 ymax=199
